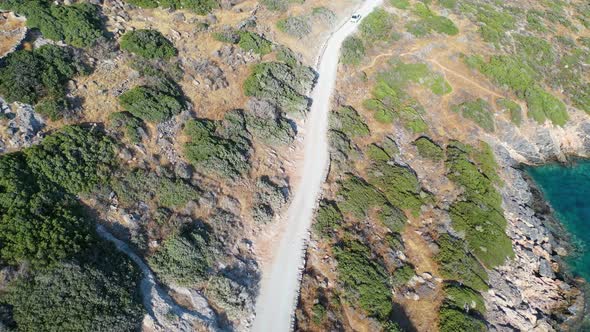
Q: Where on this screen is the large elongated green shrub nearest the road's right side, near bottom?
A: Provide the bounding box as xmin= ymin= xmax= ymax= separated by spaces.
xmin=334 ymin=240 xmax=392 ymax=321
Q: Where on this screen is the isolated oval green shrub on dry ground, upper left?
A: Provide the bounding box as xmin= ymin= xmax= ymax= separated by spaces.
xmin=121 ymin=29 xmax=177 ymax=59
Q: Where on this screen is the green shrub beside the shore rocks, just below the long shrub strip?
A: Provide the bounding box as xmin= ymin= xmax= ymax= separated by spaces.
xmin=435 ymin=234 xmax=488 ymax=291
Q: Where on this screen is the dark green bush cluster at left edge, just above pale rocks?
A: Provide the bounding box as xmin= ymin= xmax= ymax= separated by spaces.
xmin=0 ymin=45 xmax=89 ymax=115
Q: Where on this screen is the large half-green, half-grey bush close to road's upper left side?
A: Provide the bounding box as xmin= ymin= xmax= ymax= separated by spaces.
xmin=244 ymin=62 xmax=316 ymax=114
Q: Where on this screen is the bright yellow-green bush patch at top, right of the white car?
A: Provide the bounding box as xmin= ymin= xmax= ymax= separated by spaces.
xmin=406 ymin=2 xmax=459 ymax=37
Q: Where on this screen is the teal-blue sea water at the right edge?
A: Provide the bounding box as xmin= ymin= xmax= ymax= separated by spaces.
xmin=527 ymin=160 xmax=590 ymax=281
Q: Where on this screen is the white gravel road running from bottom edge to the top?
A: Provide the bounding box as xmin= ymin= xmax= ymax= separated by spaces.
xmin=252 ymin=0 xmax=383 ymax=332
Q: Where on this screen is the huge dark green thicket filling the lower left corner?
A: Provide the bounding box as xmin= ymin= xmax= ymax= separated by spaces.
xmin=0 ymin=127 xmax=143 ymax=331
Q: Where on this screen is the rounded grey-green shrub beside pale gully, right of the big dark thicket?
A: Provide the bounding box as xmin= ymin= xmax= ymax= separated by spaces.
xmin=148 ymin=230 xmax=213 ymax=286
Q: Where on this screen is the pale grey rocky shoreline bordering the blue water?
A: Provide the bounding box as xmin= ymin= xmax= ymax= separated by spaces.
xmin=484 ymin=114 xmax=590 ymax=331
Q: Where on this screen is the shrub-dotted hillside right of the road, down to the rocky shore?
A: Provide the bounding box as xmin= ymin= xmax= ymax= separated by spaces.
xmin=296 ymin=0 xmax=590 ymax=331
